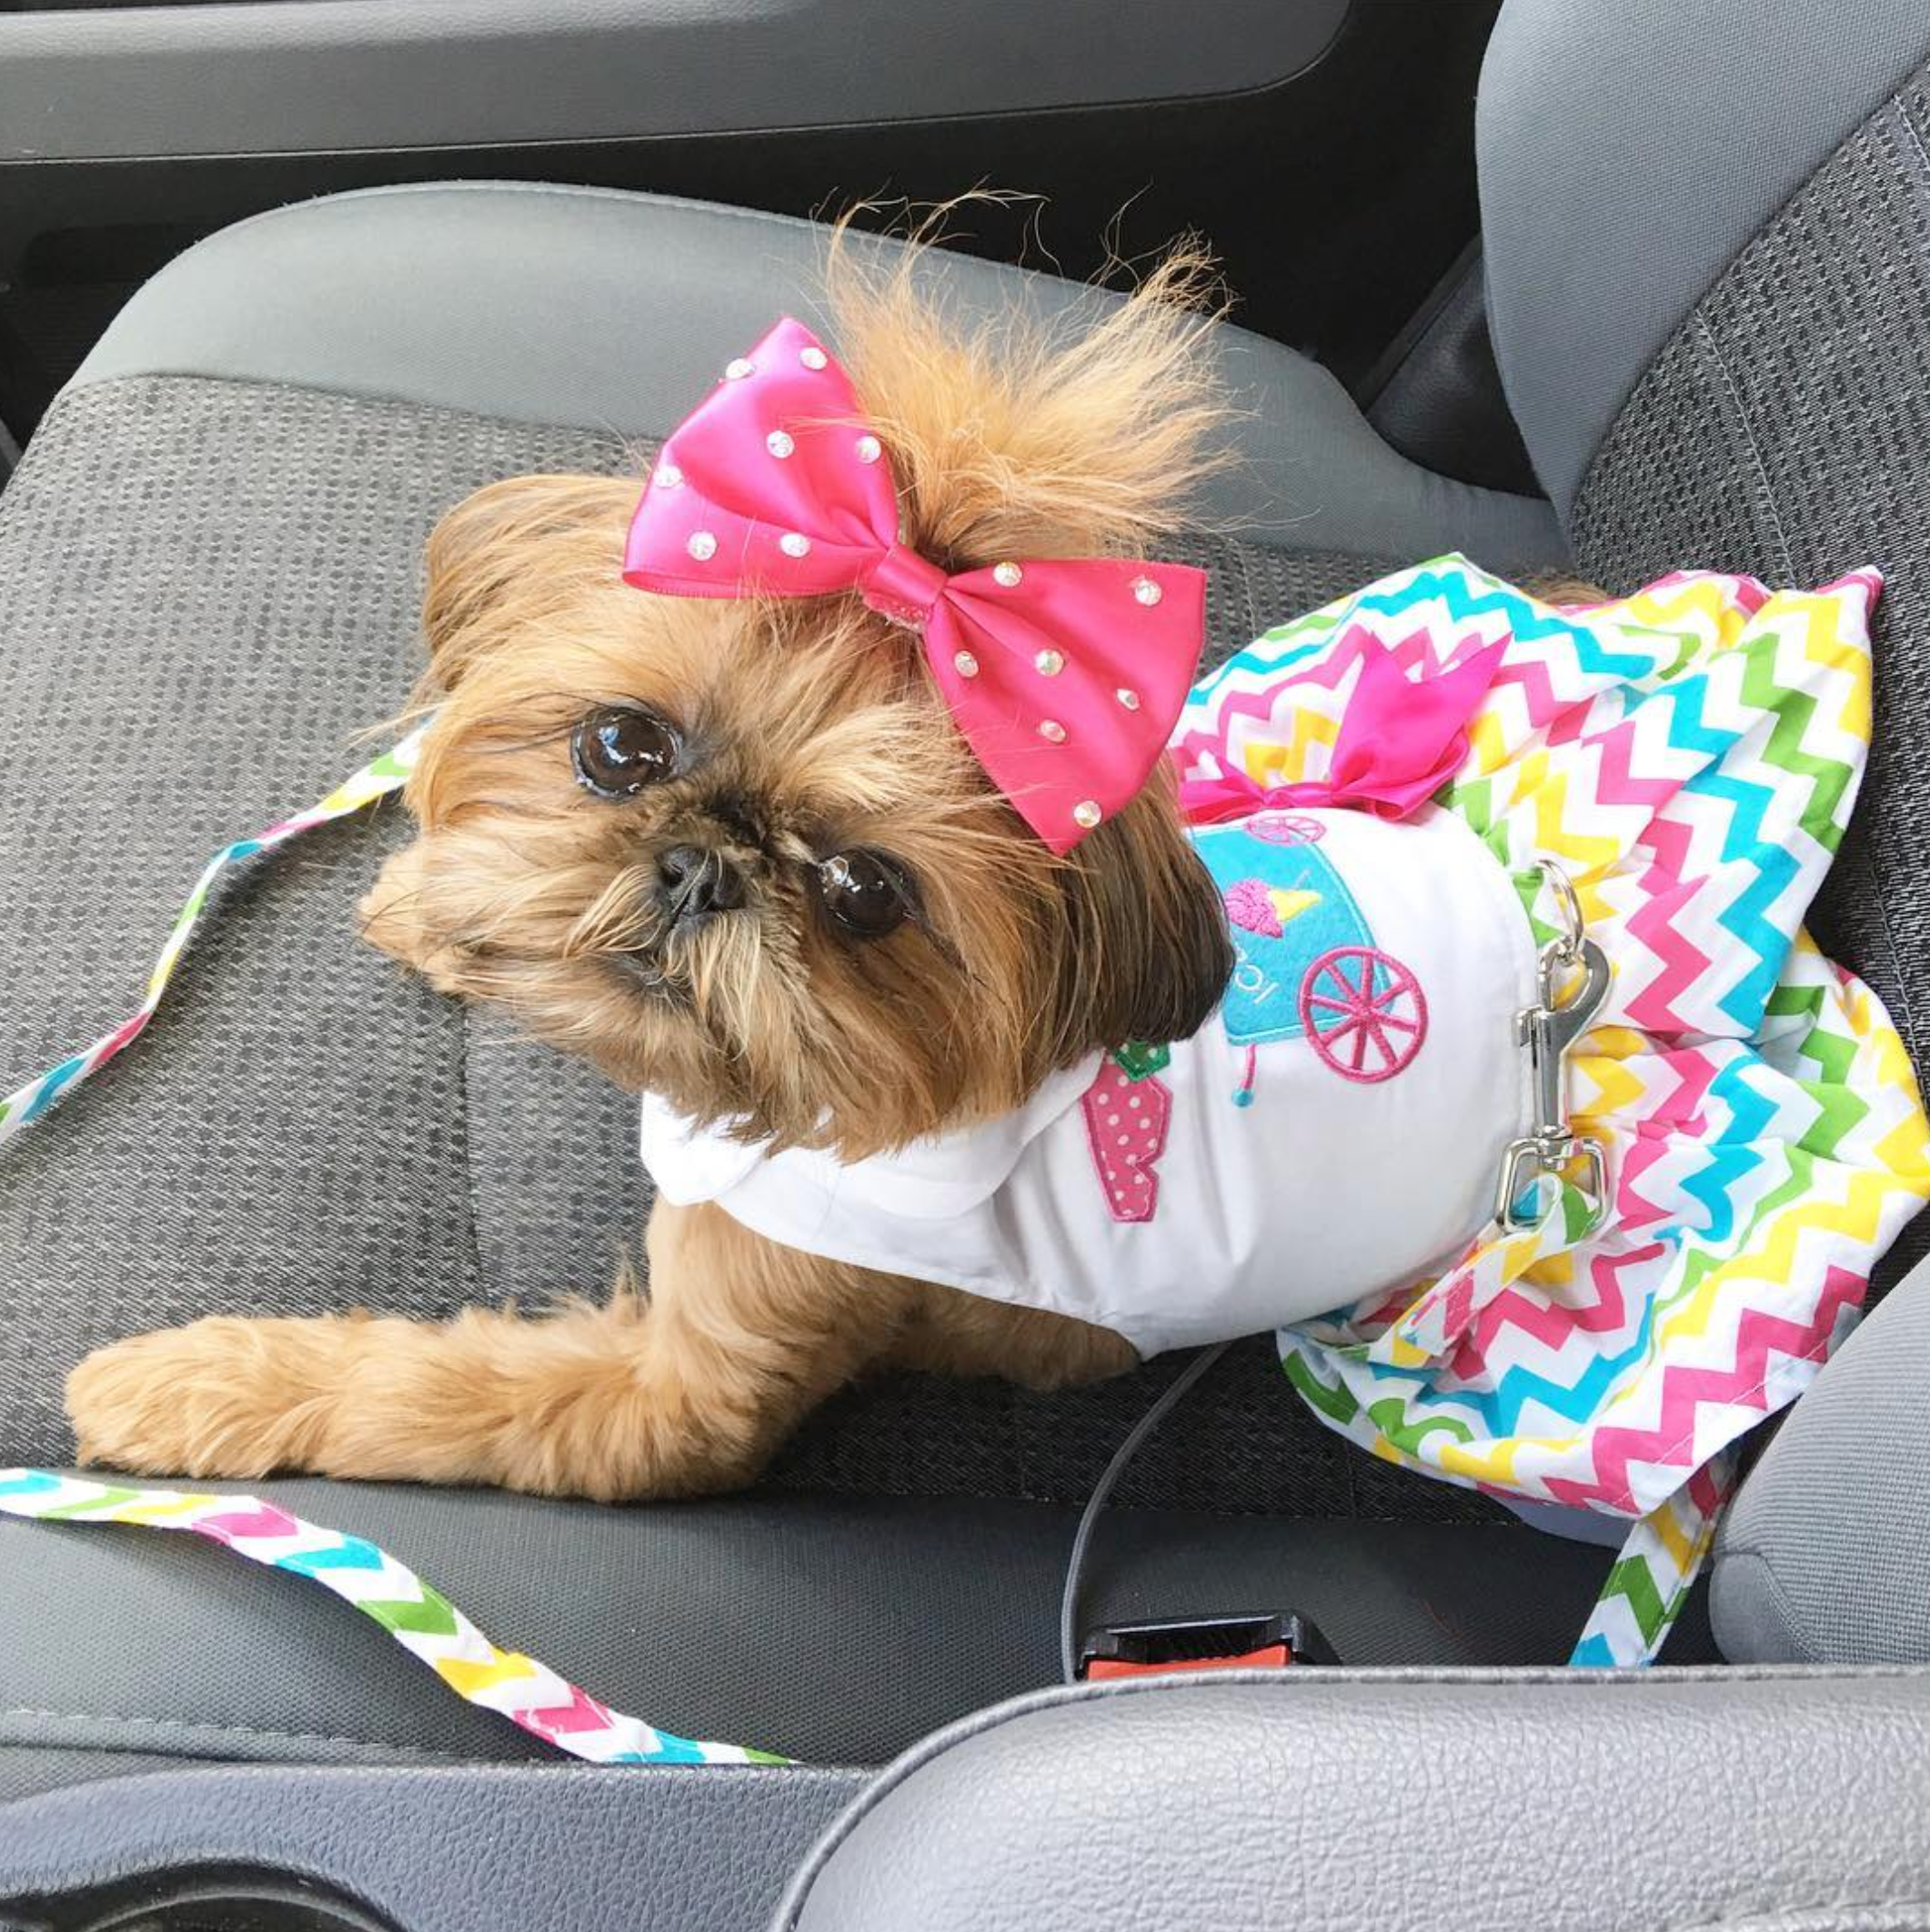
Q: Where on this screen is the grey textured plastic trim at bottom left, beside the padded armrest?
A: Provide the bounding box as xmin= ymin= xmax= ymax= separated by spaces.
xmin=0 ymin=1766 xmax=866 ymax=1932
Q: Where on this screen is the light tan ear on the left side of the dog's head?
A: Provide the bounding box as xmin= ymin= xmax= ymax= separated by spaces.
xmin=423 ymin=476 xmax=641 ymax=691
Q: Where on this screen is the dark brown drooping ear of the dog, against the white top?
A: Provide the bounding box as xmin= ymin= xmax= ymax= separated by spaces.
xmin=1051 ymin=769 xmax=1234 ymax=1064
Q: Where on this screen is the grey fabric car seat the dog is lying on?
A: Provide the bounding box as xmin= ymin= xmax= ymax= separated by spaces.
xmin=0 ymin=0 xmax=1930 ymax=1855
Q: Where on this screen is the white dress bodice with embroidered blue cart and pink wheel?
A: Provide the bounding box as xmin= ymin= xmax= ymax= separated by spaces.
xmin=643 ymin=808 xmax=1536 ymax=1354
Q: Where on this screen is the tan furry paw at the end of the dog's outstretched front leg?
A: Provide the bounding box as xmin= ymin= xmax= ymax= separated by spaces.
xmin=67 ymin=1315 xmax=347 ymax=1478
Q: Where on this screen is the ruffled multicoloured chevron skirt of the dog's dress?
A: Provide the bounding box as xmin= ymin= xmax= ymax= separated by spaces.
xmin=1177 ymin=557 xmax=1930 ymax=1664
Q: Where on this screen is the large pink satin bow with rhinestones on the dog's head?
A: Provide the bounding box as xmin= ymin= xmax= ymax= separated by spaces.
xmin=624 ymin=317 xmax=1205 ymax=852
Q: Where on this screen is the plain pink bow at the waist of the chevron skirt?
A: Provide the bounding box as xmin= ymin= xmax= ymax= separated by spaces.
xmin=1181 ymin=636 xmax=1505 ymax=825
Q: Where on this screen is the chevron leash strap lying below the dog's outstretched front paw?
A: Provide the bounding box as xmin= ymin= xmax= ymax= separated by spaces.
xmin=0 ymin=1468 xmax=789 ymax=1764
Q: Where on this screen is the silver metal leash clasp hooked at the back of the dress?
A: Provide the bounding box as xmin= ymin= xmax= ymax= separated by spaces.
xmin=1495 ymin=860 xmax=1612 ymax=1229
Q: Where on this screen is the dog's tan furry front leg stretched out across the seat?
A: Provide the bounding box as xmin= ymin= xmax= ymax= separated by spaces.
xmin=67 ymin=1203 xmax=923 ymax=1501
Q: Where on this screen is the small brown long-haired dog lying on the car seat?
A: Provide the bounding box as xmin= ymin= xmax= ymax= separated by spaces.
xmin=67 ymin=241 xmax=1232 ymax=1499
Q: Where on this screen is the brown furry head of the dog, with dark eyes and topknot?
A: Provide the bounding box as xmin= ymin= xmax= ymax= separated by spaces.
xmin=365 ymin=248 xmax=1232 ymax=1157
